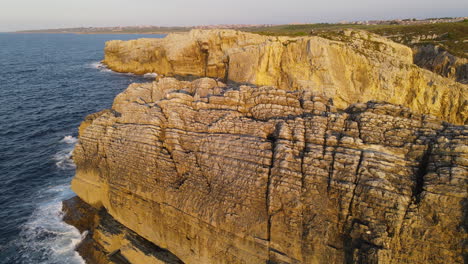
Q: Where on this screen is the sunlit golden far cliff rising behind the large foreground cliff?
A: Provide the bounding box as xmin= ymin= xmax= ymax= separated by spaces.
xmin=104 ymin=30 xmax=468 ymax=124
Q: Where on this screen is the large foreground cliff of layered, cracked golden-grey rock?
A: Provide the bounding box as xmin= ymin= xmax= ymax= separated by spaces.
xmin=72 ymin=78 xmax=468 ymax=264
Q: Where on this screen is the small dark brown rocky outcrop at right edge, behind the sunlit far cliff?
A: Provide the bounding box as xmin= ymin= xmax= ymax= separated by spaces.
xmin=413 ymin=44 xmax=468 ymax=84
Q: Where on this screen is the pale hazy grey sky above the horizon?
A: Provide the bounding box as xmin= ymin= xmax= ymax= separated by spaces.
xmin=0 ymin=0 xmax=468 ymax=31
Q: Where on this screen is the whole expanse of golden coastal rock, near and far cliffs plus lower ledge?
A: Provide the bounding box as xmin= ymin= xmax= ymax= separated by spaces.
xmin=64 ymin=30 xmax=468 ymax=264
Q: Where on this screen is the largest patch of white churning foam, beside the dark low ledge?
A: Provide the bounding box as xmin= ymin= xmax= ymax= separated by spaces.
xmin=19 ymin=184 xmax=85 ymax=264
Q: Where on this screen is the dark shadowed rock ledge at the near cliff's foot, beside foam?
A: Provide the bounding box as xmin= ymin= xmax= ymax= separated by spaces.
xmin=62 ymin=196 xmax=183 ymax=264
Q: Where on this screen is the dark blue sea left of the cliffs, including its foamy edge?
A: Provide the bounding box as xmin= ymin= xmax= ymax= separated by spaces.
xmin=0 ymin=34 xmax=162 ymax=264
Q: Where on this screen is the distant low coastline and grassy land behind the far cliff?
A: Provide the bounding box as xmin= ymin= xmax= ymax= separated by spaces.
xmin=16 ymin=20 xmax=468 ymax=58
